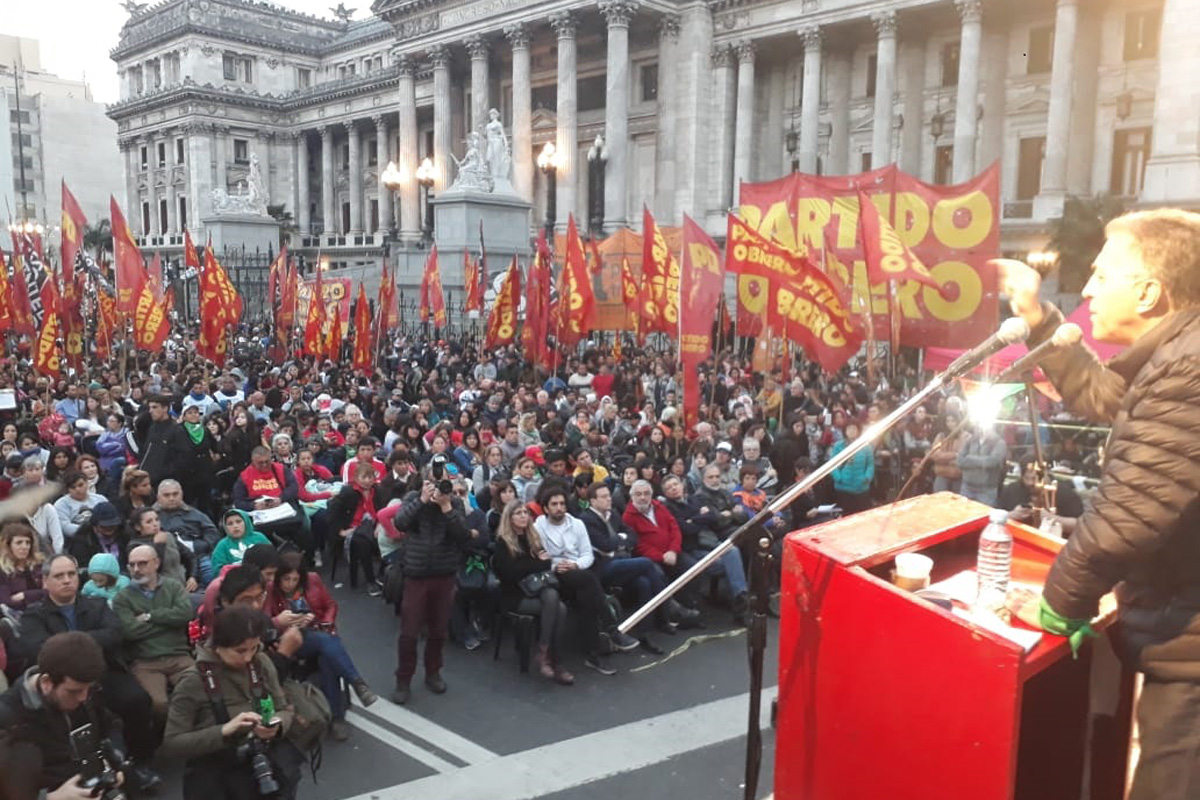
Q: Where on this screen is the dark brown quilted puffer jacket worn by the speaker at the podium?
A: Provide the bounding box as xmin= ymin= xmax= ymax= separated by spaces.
xmin=1028 ymin=306 xmax=1200 ymax=681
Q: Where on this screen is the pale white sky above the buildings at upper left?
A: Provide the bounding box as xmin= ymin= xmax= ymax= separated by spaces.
xmin=7 ymin=0 xmax=357 ymax=103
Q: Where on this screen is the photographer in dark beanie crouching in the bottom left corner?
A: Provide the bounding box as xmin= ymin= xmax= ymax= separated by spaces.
xmin=0 ymin=631 xmax=119 ymax=800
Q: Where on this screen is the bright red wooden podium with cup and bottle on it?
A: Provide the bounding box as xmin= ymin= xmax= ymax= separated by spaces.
xmin=775 ymin=493 xmax=1133 ymax=800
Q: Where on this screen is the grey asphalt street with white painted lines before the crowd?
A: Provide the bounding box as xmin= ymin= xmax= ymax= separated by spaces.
xmin=158 ymin=587 xmax=778 ymax=800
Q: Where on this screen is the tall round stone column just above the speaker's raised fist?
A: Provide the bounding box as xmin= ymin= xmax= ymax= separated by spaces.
xmin=1033 ymin=0 xmax=1079 ymax=212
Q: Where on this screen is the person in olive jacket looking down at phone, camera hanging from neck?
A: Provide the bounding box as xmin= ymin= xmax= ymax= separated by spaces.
xmin=162 ymin=606 xmax=302 ymax=800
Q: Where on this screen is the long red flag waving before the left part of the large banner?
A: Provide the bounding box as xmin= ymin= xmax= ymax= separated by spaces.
xmin=726 ymin=215 xmax=863 ymax=372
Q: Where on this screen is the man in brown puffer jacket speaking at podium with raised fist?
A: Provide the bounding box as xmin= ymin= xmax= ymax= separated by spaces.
xmin=996 ymin=210 xmax=1200 ymax=800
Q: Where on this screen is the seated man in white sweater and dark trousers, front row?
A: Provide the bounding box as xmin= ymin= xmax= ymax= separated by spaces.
xmin=534 ymin=485 xmax=637 ymax=673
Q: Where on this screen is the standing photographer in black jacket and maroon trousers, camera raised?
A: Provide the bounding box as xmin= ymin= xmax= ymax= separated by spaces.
xmin=391 ymin=463 xmax=470 ymax=705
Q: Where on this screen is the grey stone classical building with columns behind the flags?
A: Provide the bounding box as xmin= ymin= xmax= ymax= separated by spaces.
xmin=109 ymin=0 xmax=1185 ymax=282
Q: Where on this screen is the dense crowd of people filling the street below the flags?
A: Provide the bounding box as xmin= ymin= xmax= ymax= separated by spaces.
xmin=0 ymin=331 xmax=1094 ymax=799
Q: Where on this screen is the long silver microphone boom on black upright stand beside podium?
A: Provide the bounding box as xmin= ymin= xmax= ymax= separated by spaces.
xmin=617 ymin=365 xmax=955 ymax=800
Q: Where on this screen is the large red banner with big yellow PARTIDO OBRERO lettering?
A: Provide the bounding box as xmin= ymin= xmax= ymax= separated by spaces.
xmin=737 ymin=166 xmax=1001 ymax=347
